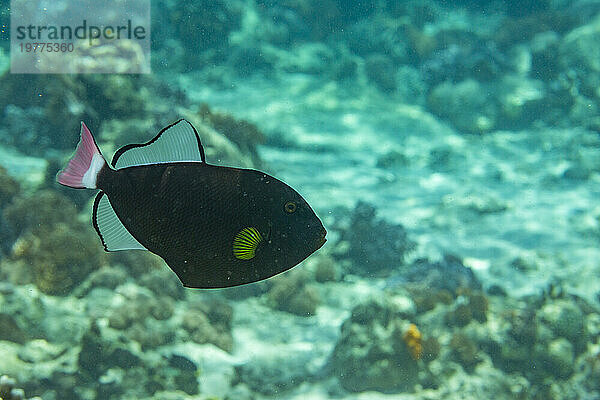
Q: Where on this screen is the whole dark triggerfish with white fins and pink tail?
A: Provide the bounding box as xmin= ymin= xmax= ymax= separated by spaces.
xmin=57 ymin=120 xmax=327 ymax=288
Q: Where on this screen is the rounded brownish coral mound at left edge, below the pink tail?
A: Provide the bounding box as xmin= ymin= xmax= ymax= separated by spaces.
xmin=2 ymin=190 xmax=106 ymax=295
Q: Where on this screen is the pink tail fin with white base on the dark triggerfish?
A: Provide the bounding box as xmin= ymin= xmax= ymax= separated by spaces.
xmin=57 ymin=122 xmax=106 ymax=189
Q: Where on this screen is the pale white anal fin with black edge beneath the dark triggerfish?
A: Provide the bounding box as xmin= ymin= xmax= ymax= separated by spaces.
xmin=92 ymin=192 xmax=147 ymax=251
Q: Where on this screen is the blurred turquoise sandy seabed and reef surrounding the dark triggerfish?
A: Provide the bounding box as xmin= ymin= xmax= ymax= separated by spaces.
xmin=0 ymin=0 xmax=600 ymax=400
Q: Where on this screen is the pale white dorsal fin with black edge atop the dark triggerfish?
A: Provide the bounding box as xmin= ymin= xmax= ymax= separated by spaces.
xmin=112 ymin=119 xmax=205 ymax=169
